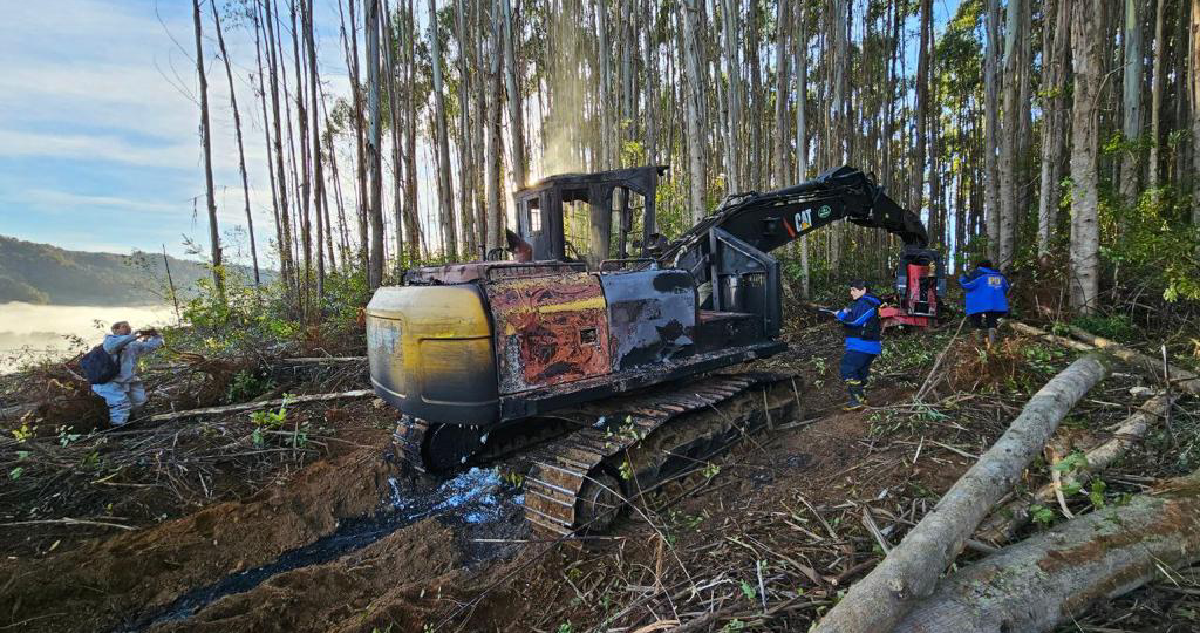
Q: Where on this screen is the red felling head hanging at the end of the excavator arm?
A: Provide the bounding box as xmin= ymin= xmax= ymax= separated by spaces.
xmin=880 ymin=246 xmax=946 ymax=330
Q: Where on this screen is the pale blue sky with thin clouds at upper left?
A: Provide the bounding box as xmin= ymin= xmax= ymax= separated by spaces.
xmin=0 ymin=0 xmax=347 ymax=258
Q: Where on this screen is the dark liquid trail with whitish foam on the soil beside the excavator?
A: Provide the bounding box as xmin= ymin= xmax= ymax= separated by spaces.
xmin=113 ymin=468 xmax=523 ymax=633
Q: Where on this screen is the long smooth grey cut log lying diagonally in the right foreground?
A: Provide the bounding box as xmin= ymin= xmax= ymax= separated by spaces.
xmin=815 ymin=355 xmax=1109 ymax=633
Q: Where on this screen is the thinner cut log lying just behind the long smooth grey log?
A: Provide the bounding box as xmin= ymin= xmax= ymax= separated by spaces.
xmin=976 ymin=393 xmax=1177 ymax=543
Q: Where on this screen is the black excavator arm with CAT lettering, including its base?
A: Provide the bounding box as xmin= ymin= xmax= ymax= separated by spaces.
xmin=659 ymin=167 xmax=929 ymax=336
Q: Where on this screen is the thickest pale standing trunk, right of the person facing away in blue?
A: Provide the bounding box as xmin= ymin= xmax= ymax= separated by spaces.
xmin=1070 ymin=0 xmax=1099 ymax=314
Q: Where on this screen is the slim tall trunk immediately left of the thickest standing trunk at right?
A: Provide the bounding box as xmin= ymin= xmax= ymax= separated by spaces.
xmin=1038 ymin=0 xmax=1073 ymax=258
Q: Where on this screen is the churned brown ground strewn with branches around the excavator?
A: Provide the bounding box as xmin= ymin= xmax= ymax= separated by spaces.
xmin=0 ymin=324 xmax=1200 ymax=633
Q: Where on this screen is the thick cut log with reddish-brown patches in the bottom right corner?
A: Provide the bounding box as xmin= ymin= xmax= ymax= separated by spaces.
xmin=894 ymin=471 xmax=1200 ymax=633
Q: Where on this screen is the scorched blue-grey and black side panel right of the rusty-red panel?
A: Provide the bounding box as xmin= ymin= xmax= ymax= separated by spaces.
xmin=600 ymin=270 xmax=696 ymax=372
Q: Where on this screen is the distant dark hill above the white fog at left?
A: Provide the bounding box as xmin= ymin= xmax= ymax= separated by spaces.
xmin=0 ymin=235 xmax=265 ymax=306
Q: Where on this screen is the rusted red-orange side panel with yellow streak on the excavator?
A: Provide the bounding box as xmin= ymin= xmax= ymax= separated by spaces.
xmin=486 ymin=273 xmax=611 ymax=393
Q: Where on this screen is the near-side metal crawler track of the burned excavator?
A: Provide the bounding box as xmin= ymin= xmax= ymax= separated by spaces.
xmin=524 ymin=373 xmax=798 ymax=538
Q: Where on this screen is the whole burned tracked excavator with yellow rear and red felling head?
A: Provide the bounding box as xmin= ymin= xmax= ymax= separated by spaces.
xmin=367 ymin=167 xmax=941 ymax=536
